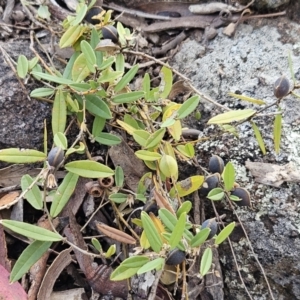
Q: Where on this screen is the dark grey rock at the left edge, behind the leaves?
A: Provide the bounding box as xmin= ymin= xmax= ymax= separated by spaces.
xmin=0 ymin=39 xmax=51 ymax=150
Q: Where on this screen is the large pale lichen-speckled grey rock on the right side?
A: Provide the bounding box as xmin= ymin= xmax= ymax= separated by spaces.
xmin=172 ymin=13 xmax=300 ymax=300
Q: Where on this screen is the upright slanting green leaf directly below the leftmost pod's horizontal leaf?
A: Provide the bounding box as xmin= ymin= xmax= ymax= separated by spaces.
xmin=50 ymin=173 xmax=78 ymax=218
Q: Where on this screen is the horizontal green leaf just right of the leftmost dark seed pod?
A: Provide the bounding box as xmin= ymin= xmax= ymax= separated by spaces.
xmin=65 ymin=160 xmax=114 ymax=178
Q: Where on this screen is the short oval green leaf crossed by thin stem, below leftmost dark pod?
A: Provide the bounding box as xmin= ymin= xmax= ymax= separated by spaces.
xmin=21 ymin=174 xmax=43 ymax=210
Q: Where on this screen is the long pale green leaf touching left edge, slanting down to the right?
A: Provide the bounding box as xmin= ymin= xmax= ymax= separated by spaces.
xmin=0 ymin=220 xmax=63 ymax=242
